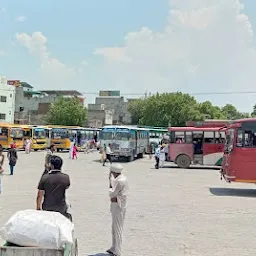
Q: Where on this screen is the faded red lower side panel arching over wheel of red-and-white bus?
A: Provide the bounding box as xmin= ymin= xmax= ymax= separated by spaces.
xmin=169 ymin=143 xmax=194 ymax=162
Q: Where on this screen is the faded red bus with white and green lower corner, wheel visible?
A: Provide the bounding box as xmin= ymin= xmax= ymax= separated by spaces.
xmin=168 ymin=127 xmax=225 ymax=168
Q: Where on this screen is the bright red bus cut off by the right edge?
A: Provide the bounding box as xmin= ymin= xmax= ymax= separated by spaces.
xmin=221 ymin=118 xmax=256 ymax=183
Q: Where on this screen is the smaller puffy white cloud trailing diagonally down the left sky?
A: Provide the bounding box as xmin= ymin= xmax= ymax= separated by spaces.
xmin=16 ymin=32 xmax=76 ymax=84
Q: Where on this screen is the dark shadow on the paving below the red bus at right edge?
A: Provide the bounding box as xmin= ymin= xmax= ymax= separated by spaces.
xmin=209 ymin=188 xmax=256 ymax=198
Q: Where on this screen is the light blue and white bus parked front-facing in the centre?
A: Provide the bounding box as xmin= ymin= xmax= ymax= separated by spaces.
xmin=100 ymin=126 xmax=149 ymax=161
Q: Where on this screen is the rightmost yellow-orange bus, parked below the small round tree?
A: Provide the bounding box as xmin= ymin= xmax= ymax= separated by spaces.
xmin=47 ymin=125 xmax=79 ymax=151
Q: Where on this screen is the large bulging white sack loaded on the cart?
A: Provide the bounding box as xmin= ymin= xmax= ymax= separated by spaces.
xmin=0 ymin=210 xmax=74 ymax=249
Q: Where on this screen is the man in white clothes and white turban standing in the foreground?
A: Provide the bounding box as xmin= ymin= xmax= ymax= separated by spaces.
xmin=107 ymin=164 xmax=129 ymax=256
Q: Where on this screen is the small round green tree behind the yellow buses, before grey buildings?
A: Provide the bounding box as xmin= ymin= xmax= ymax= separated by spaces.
xmin=46 ymin=98 xmax=87 ymax=126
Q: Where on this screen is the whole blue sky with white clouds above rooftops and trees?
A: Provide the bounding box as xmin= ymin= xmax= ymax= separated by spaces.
xmin=0 ymin=0 xmax=256 ymax=112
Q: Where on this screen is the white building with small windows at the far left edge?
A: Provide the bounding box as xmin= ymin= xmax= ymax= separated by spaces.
xmin=0 ymin=76 xmax=15 ymax=124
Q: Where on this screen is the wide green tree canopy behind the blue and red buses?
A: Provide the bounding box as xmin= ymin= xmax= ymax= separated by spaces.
xmin=128 ymin=92 xmax=250 ymax=127
